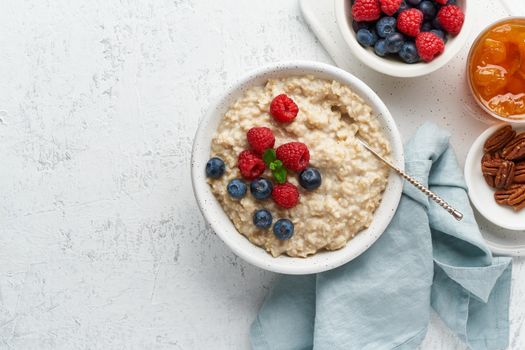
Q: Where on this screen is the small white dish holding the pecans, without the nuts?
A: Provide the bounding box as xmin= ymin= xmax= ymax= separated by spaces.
xmin=465 ymin=123 xmax=525 ymax=231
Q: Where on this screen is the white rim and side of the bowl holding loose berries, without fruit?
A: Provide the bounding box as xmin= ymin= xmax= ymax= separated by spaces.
xmin=334 ymin=0 xmax=474 ymax=78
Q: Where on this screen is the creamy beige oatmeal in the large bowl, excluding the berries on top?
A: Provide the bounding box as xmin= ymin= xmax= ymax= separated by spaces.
xmin=208 ymin=76 xmax=390 ymax=257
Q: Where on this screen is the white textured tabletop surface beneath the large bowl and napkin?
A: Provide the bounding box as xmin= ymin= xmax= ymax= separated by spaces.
xmin=0 ymin=0 xmax=525 ymax=349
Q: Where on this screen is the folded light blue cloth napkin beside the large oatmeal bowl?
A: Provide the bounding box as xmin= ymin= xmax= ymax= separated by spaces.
xmin=250 ymin=124 xmax=512 ymax=350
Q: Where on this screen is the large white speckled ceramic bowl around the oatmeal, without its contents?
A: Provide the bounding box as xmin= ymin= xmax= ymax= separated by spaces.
xmin=191 ymin=61 xmax=404 ymax=274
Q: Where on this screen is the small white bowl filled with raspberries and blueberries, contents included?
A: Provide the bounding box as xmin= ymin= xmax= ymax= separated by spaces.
xmin=335 ymin=0 xmax=472 ymax=77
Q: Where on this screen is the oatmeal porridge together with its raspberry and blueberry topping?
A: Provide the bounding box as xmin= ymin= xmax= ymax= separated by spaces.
xmin=208 ymin=76 xmax=390 ymax=257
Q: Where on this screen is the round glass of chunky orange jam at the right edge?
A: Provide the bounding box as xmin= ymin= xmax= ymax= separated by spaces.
xmin=468 ymin=18 xmax=525 ymax=119
